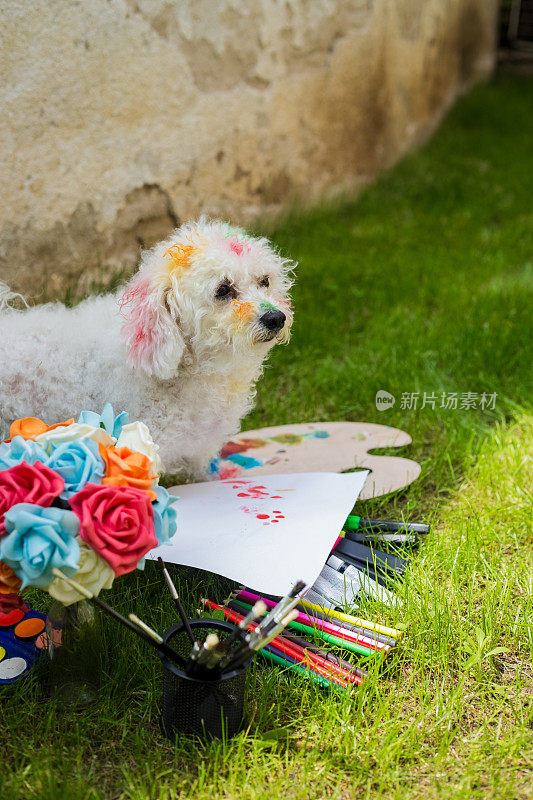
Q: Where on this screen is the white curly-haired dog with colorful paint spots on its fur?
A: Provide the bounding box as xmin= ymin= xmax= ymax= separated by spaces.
xmin=0 ymin=218 xmax=294 ymax=479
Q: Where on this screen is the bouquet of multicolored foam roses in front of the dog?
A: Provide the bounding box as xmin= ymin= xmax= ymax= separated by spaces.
xmin=0 ymin=403 xmax=177 ymax=605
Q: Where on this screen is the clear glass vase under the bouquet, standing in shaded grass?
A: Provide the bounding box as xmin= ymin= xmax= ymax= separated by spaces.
xmin=46 ymin=600 xmax=101 ymax=710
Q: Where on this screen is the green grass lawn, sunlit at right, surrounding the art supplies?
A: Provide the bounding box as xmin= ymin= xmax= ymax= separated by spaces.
xmin=0 ymin=79 xmax=533 ymax=800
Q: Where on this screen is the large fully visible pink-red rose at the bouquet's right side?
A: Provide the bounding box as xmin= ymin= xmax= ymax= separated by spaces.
xmin=69 ymin=483 xmax=157 ymax=576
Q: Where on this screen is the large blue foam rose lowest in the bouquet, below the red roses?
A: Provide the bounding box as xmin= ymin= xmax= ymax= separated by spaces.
xmin=0 ymin=503 xmax=80 ymax=589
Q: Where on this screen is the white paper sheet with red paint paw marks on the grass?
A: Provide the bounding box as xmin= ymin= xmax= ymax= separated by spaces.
xmin=146 ymin=471 xmax=368 ymax=595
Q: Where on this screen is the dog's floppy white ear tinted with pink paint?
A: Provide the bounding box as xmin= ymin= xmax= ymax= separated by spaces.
xmin=119 ymin=273 xmax=185 ymax=380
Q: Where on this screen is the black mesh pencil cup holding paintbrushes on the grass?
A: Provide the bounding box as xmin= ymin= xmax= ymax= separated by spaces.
xmin=160 ymin=618 xmax=250 ymax=739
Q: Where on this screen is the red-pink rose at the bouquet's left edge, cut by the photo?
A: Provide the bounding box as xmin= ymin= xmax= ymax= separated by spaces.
xmin=0 ymin=461 xmax=65 ymax=536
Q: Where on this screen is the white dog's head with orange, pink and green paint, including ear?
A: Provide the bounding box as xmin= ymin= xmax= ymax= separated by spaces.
xmin=121 ymin=220 xmax=293 ymax=378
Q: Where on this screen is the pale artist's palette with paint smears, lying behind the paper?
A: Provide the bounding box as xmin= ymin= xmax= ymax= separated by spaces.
xmin=213 ymin=422 xmax=420 ymax=500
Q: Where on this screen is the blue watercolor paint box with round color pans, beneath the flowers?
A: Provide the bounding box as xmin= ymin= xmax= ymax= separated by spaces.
xmin=0 ymin=609 xmax=45 ymax=685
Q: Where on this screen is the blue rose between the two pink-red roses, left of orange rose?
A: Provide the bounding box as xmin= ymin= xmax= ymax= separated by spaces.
xmin=46 ymin=437 xmax=105 ymax=500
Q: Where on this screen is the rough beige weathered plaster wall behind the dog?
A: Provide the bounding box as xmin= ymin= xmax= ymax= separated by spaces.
xmin=0 ymin=0 xmax=497 ymax=297
